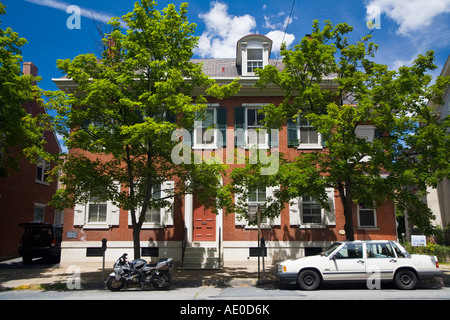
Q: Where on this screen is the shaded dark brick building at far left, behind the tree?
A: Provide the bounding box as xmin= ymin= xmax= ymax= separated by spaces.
xmin=0 ymin=62 xmax=62 ymax=258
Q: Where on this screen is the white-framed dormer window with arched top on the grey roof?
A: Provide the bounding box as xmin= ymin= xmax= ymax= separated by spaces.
xmin=236 ymin=34 xmax=272 ymax=77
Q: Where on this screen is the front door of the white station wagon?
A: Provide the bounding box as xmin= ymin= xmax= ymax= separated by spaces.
xmin=328 ymin=243 xmax=366 ymax=280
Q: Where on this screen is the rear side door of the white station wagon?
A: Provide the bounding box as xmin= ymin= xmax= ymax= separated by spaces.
xmin=366 ymin=242 xmax=398 ymax=280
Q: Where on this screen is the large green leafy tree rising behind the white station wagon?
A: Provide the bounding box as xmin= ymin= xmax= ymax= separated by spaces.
xmin=257 ymin=21 xmax=450 ymax=240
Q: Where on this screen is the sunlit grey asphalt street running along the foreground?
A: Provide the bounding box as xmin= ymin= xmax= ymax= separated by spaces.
xmin=0 ymin=285 xmax=450 ymax=302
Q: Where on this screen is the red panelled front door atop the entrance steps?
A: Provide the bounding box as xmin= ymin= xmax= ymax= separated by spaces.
xmin=193 ymin=198 xmax=216 ymax=241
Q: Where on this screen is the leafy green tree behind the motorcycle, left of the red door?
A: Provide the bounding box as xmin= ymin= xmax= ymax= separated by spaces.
xmin=48 ymin=0 xmax=240 ymax=258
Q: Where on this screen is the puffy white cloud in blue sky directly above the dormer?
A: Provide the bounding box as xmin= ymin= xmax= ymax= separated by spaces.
xmin=195 ymin=1 xmax=295 ymax=58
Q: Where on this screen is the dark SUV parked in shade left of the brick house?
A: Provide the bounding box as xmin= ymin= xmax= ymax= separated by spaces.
xmin=19 ymin=222 xmax=62 ymax=264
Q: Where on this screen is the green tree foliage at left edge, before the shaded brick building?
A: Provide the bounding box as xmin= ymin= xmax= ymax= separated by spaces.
xmin=0 ymin=2 xmax=44 ymax=176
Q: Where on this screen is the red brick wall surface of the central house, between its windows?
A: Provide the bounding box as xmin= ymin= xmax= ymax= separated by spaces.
xmin=60 ymin=95 xmax=396 ymax=241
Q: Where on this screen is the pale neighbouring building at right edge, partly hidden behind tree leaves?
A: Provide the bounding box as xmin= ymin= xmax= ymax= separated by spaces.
xmin=427 ymin=55 xmax=450 ymax=228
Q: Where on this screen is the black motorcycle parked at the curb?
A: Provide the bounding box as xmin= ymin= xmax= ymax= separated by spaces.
xmin=106 ymin=253 xmax=173 ymax=291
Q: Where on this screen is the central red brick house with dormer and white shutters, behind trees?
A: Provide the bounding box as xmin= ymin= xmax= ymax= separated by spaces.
xmin=54 ymin=35 xmax=397 ymax=267
